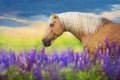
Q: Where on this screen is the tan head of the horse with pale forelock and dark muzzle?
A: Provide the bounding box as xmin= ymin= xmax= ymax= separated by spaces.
xmin=42 ymin=13 xmax=65 ymax=47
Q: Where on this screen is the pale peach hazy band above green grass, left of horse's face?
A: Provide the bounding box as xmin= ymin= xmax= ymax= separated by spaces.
xmin=0 ymin=23 xmax=46 ymax=37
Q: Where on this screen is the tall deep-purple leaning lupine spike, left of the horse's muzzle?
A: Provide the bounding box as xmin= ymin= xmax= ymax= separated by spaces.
xmin=27 ymin=49 xmax=36 ymax=71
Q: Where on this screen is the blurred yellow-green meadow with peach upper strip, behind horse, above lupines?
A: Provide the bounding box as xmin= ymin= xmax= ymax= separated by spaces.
xmin=0 ymin=25 xmax=83 ymax=53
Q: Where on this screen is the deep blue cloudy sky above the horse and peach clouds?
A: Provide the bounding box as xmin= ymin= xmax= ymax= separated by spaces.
xmin=0 ymin=0 xmax=120 ymax=27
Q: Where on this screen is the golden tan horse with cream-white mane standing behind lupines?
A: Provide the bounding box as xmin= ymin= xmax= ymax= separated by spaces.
xmin=43 ymin=12 xmax=120 ymax=55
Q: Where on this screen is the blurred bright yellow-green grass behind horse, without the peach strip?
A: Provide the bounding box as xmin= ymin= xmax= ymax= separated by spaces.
xmin=0 ymin=33 xmax=83 ymax=52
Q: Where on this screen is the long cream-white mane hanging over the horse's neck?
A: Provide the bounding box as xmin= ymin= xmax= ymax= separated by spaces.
xmin=57 ymin=12 xmax=110 ymax=34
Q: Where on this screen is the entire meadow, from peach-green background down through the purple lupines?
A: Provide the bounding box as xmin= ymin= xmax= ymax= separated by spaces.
xmin=0 ymin=23 xmax=120 ymax=80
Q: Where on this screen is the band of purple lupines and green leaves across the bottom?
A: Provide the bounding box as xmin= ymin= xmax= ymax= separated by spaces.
xmin=0 ymin=38 xmax=120 ymax=80
